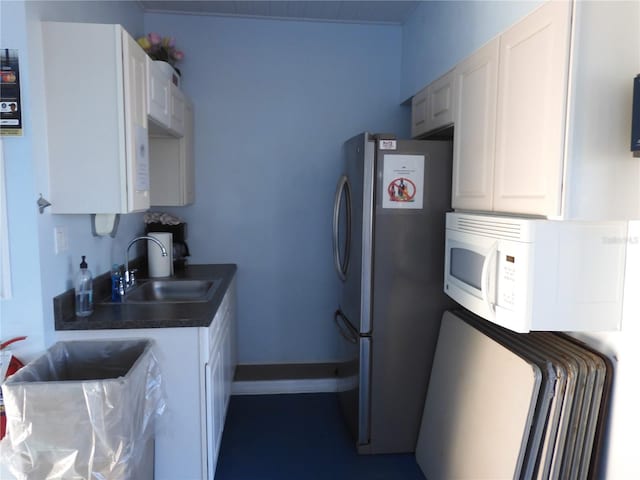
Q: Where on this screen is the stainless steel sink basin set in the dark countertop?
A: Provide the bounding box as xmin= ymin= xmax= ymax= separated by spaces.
xmin=124 ymin=279 xmax=222 ymax=303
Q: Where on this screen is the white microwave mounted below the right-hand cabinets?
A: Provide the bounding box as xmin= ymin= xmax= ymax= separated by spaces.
xmin=444 ymin=212 xmax=627 ymax=332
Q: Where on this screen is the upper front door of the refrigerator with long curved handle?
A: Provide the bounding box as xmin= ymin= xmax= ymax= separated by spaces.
xmin=340 ymin=133 xmax=375 ymax=335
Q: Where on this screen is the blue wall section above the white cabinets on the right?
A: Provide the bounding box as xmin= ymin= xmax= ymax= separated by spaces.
xmin=400 ymin=0 xmax=542 ymax=99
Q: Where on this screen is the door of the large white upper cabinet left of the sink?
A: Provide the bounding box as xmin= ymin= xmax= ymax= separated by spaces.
xmin=122 ymin=30 xmax=150 ymax=212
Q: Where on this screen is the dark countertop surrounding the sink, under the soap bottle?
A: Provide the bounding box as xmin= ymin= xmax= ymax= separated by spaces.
xmin=53 ymin=264 xmax=237 ymax=330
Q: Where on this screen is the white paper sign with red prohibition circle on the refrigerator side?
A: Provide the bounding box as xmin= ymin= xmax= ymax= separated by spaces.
xmin=382 ymin=154 xmax=424 ymax=209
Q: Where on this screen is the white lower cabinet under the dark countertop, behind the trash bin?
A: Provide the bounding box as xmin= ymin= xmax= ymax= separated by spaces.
xmin=56 ymin=280 xmax=236 ymax=480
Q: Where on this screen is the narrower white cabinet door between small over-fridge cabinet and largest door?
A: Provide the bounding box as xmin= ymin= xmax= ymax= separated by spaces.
xmin=451 ymin=38 xmax=499 ymax=210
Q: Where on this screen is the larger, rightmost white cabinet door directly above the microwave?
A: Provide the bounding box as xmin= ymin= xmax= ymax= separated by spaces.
xmin=493 ymin=2 xmax=572 ymax=216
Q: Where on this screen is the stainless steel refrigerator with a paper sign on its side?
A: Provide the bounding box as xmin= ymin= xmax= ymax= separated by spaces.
xmin=333 ymin=133 xmax=455 ymax=454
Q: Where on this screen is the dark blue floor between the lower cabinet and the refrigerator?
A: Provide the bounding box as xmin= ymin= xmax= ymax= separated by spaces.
xmin=216 ymin=393 xmax=424 ymax=480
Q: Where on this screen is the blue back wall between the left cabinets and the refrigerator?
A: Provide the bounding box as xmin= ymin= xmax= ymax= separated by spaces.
xmin=145 ymin=14 xmax=409 ymax=363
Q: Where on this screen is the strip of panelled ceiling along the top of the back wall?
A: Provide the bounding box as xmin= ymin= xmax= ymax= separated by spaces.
xmin=139 ymin=0 xmax=418 ymax=25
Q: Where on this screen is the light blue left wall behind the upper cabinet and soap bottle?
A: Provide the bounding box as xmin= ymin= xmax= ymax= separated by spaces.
xmin=0 ymin=1 xmax=143 ymax=360
